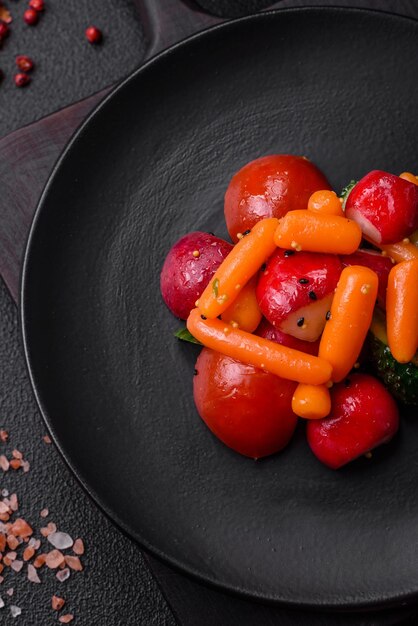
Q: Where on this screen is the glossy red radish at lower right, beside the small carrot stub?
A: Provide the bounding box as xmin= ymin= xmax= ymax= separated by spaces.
xmin=306 ymin=374 xmax=399 ymax=469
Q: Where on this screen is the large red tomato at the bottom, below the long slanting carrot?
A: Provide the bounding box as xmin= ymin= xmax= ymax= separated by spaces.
xmin=193 ymin=348 xmax=297 ymax=459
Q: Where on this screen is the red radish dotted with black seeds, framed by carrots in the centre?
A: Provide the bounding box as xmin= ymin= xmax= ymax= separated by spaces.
xmin=257 ymin=249 xmax=342 ymax=341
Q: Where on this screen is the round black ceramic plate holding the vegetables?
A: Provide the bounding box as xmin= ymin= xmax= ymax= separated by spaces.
xmin=22 ymin=9 xmax=418 ymax=607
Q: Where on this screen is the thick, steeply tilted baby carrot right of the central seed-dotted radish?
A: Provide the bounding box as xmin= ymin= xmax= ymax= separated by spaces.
xmin=319 ymin=265 xmax=379 ymax=382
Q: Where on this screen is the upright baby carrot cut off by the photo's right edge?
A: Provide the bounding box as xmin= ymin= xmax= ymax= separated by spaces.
xmin=386 ymin=260 xmax=418 ymax=363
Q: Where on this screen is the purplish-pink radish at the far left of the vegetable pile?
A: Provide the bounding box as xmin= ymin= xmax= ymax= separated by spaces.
xmin=160 ymin=231 xmax=232 ymax=320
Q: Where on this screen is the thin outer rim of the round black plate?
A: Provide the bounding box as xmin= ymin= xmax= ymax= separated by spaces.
xmin=18 ymin=4 xmax=418 ymax=612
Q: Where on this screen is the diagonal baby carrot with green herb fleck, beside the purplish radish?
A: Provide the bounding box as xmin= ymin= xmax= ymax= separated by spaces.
xmin=198 ymin=217 xmax=279 ymax=319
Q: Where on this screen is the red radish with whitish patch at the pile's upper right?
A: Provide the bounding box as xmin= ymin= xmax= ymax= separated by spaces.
xmin=345 ymin=170 xmax=418 ymax=244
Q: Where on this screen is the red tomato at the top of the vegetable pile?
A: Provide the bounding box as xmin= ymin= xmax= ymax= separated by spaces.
xmin=224 ymin=154 xmax=331 ymax=242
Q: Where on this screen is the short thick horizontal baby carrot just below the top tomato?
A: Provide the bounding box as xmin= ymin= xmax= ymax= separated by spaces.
xmin=274 ymin=210 xmax=362 ymax=254
